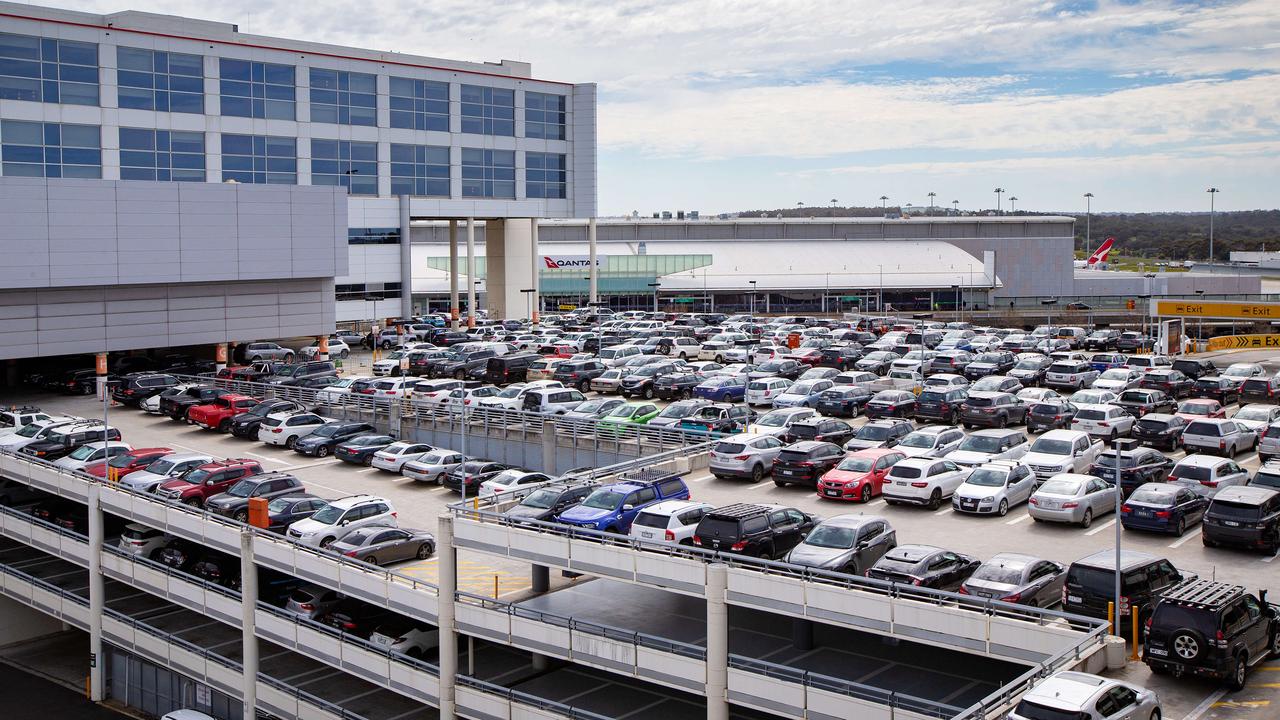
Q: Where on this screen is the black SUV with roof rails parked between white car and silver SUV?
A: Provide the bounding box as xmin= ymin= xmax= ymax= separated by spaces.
xmin=694 ymin=502 xmax=818 ymax=560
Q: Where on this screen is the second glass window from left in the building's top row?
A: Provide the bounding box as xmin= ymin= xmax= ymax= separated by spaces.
xmin=115 ymin=47 xmax=205 ymax=114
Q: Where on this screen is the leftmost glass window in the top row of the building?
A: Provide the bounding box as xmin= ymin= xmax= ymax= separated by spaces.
xmin=0 ymin=32 xmax=97 ymax=105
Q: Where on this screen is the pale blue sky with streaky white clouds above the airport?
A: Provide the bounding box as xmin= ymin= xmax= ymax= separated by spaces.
xmin=50 ymin=0 xmax=1280 ymax=215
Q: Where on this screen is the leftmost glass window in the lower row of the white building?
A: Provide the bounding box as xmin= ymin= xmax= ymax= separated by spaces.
xmin=0 ymin=120 xmax=102 ymax=178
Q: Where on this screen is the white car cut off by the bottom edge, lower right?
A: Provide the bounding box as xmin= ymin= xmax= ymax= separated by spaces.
xmin=1007 ymin=670 xmax=1161 ymax=720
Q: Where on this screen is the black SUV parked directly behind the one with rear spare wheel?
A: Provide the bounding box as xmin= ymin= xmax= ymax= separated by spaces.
xmin=1062 ymin=550 xmax=1183 ymax=625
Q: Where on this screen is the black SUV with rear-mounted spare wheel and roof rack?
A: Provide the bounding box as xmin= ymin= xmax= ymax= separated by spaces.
xmin=1142 ymin=580 xmax=1280 ymax=691
